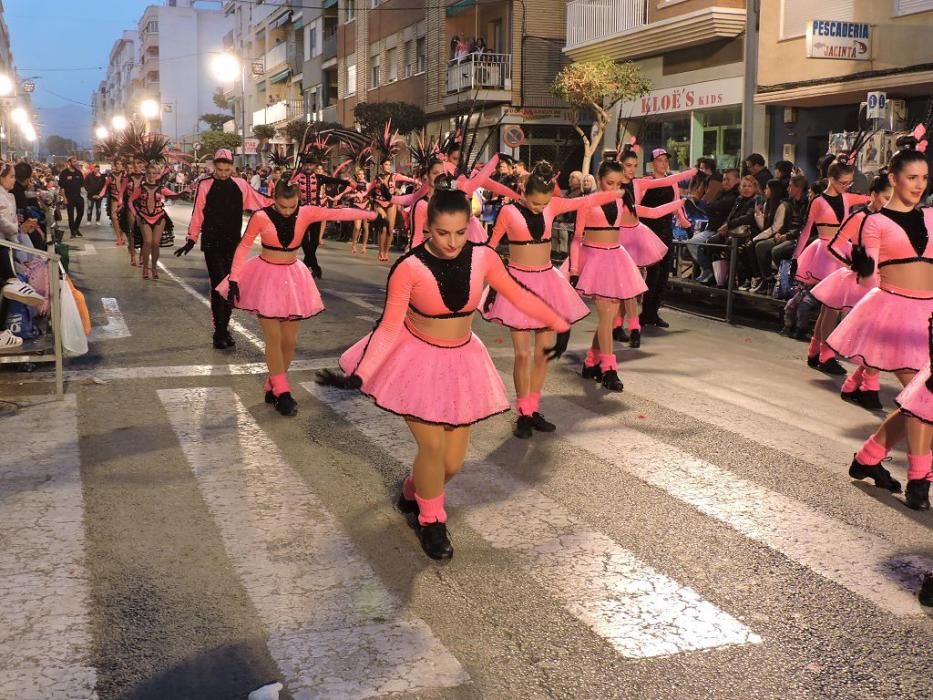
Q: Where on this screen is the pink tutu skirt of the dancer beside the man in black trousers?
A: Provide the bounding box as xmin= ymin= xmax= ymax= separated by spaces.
xmin=216 ymin=255 xmax=324 ymax=321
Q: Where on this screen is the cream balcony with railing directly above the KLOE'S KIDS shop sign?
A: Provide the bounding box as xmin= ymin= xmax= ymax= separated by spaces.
xmin=564 ymin=0 xmax=745 ymax=61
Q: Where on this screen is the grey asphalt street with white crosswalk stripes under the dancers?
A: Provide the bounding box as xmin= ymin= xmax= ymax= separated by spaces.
xmin=0 ymin=200 xmax=933 ymax=700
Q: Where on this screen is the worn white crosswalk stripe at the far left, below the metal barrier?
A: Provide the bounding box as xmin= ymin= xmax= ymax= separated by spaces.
xmin=0 ymin=396 xmax=97 ymax=700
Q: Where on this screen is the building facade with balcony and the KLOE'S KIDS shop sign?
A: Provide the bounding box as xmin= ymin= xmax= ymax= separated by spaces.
xmin=564 ymin=0 xmax=769 ymax=170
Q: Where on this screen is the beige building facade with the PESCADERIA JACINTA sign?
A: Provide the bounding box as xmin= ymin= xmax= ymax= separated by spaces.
xmin=755 ymin=0 xmax=933 ymax=176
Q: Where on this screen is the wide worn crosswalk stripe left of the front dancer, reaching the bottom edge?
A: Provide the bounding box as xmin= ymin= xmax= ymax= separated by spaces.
xmin=158 ymin=388 xmax=468 ymax=698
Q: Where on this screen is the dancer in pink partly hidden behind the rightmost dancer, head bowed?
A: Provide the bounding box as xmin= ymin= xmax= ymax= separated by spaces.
xmin=811 ymin=170 xmax=891 ymax=411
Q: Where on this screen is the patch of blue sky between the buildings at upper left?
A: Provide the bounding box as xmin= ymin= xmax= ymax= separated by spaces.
xmin=3 ymin=0 xmax=156 ymax=142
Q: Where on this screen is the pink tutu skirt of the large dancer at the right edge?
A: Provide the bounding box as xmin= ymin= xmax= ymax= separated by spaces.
xmin=826 ymin=288 xmax=933 ymax=372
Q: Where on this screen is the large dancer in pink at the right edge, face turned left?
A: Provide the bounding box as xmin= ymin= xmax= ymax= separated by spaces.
xmin=826 ymin=136 xmax=933 ymax=510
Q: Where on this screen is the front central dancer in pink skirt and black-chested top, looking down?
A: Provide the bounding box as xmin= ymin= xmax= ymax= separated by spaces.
xmin=319 ymin=180 xmax=570 ymax=559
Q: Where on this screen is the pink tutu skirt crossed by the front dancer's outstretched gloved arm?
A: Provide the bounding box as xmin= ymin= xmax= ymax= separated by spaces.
xmin=479 ymin=265 xmax=590 ymax=331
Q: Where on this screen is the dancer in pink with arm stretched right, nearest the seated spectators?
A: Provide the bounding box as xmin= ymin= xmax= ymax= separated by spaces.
xmin=566 ymin=154 xmax=683 ymax=391
